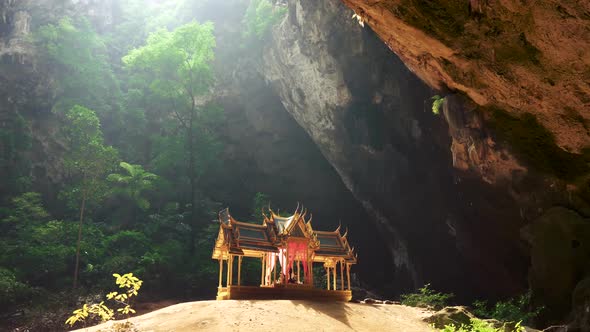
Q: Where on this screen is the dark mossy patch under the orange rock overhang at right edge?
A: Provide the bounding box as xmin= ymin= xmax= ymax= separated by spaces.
xmin=490 ymin=107 xmax=590 ymax=180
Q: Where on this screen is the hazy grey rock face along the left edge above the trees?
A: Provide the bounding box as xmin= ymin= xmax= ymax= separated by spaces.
xmin=0 ymin=0 xmax=61 ymax=200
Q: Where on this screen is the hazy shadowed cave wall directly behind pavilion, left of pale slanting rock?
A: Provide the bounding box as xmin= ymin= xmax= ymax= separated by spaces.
xmin=187 ymin=0 xmax=391 ymax=289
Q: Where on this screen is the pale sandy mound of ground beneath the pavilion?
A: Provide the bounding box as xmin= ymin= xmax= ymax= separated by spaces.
xmin=73 ymin=300 xmax=433 ymax=332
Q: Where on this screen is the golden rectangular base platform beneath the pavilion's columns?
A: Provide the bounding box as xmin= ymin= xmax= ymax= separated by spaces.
xmin=217 ymin=286 xmax=352 ymax=302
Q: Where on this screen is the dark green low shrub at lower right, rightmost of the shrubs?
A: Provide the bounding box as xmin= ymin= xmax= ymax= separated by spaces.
xmin=473 ymin=292 xmax=543 ymax=324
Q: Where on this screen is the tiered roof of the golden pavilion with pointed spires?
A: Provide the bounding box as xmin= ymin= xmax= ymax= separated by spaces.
xmin=212 ymin=206 xmax=356 ymax=263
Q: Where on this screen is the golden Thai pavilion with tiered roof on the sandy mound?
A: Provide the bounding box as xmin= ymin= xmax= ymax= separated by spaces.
xmin=212 ymin=206 xmax=357 ymax=301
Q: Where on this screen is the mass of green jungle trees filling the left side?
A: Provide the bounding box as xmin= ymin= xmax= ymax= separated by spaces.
xmin=0 ymin=0 xmax=239 ymax=329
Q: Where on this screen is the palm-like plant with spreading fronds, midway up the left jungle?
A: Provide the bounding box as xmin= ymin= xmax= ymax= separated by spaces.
xmin=107 ymin=161 xmax=158 ymax=210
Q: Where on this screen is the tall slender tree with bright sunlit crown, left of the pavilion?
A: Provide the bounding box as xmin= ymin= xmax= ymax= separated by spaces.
xmin=123 ymin=22 xmax=219 ymax=251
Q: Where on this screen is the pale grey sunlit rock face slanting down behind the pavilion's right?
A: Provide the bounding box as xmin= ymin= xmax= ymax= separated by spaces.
xmin=263 ymin=1 xmax=423 ymax=290
